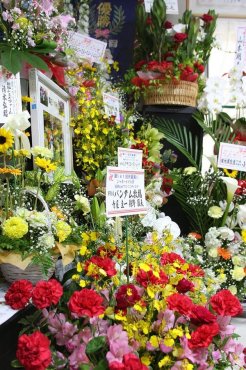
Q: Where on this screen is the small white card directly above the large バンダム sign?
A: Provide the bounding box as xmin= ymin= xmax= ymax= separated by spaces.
xmin=118 ymin=148 xmax=143 ymax=170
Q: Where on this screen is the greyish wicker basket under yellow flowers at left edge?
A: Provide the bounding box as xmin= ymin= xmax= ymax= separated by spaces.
xmin=0 ymin=262 xmax=55 ymax=284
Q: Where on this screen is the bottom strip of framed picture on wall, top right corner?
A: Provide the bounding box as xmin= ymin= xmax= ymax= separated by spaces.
xmin=186 ymin=0 xmax=246 ymax=18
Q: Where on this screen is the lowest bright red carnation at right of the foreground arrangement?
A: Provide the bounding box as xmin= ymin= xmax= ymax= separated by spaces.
xmin=188 ymin=322 xmax=219 ymax=349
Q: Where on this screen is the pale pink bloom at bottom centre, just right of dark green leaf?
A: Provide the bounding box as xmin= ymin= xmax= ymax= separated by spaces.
xmin=106 ymin=324 xmax=132 ymax=363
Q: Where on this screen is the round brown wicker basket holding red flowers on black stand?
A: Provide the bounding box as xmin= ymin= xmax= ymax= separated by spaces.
xmin=144 ymin=81 xmax=198 ymax=107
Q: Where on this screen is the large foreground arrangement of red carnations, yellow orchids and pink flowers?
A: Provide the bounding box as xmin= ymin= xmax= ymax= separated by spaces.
xmin=5 ymin=230 xmax=244 ymax=370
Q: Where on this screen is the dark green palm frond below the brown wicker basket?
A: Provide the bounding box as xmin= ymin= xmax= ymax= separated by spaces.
xmin=153 ymin=117 xmax=201 ymax=168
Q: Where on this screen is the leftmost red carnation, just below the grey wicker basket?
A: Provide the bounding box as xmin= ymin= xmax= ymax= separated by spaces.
xmin=5 ymin=280 xmax=33 ymax=310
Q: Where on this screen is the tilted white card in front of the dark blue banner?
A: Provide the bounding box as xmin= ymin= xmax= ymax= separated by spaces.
xmin=69 ymin=32 xmax=107 ymax=63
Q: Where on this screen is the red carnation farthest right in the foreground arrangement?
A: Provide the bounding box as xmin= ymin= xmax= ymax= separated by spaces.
xmin=209 ymin=289 xmax=243 ymax=316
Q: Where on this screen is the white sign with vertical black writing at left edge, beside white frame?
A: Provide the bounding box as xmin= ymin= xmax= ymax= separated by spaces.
xmin=0 ymin=72 xmax=22 ymax=123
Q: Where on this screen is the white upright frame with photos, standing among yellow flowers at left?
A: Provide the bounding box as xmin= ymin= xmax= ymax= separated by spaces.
xmin=29 ymin=69 xmax=73 ymax=175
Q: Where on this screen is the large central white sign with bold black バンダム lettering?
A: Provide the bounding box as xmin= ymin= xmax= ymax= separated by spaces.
xmin=106 ymin=167 xmax=147 ymax=217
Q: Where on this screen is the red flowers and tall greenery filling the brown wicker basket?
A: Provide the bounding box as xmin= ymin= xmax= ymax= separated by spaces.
xmin=126 ymin=0 xmax=217 ymax=98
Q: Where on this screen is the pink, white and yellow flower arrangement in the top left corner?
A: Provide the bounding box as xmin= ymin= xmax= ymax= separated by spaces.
xmin=0 ymin=0 xmax=75 ymax=74
